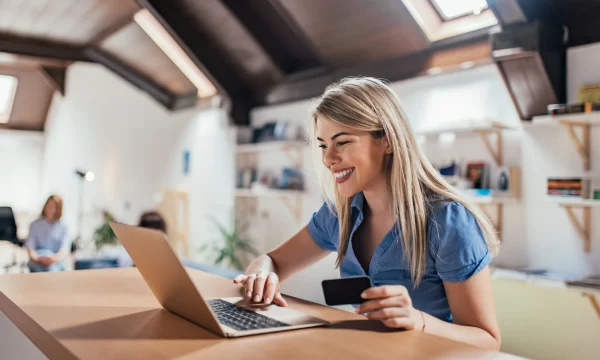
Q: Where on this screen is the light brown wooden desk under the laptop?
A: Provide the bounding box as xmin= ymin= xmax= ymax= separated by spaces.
xmin=0 ymin=268 xmax=513 ymax=360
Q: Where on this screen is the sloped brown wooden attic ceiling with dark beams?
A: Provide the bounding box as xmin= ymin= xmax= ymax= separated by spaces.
xmin=0 ymin=0 xmax=600 ymax=129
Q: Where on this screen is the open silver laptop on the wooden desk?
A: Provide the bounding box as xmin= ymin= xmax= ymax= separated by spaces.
xmin=110 ymin=222 xmax=329 ymax=337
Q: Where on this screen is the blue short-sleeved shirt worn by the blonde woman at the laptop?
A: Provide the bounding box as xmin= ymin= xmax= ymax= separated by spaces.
xmin=308 ymin=193 xmax=492 ymax=322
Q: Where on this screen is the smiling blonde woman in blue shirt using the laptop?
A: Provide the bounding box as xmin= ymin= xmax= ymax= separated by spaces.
xmin=234 ymin=78 xmax=500 ymax=349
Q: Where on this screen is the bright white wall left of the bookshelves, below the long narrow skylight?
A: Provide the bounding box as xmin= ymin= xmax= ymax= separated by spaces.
xmin=42 ymin=63 xmax=233 ymax=257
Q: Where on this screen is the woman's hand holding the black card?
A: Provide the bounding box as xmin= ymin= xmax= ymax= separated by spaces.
xmin=356 ymin=285 xmax=423 ymax=330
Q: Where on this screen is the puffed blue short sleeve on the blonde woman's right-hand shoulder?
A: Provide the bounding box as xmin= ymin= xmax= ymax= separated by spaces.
xmin=428 ymin=202 xmax=492 ymax=282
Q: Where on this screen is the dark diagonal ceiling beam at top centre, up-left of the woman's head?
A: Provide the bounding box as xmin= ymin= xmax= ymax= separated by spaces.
xmin=221 ymin=0 xmax=323 ymax=74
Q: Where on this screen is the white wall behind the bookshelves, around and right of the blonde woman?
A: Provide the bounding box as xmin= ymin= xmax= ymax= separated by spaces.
xmin=251 ymin=56 xmax=600 ymax=301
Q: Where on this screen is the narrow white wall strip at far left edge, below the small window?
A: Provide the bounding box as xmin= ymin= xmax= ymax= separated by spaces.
xmin=0 ymin=130 xmax=44 ymax=238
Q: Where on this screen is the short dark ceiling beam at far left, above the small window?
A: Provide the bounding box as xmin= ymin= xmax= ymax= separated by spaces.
xmin=0 ymin=35 xmax=90 ymax=62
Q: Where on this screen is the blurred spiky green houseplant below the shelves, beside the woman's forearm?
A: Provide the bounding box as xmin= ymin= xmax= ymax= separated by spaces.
xmin=200 ymin=219 xmax=258 ymax=270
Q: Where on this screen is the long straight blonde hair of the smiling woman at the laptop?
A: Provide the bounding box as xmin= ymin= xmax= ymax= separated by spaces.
xmin=312 ymin=77 xmax=499 ymax=287
